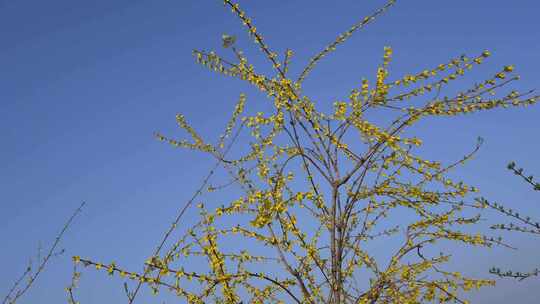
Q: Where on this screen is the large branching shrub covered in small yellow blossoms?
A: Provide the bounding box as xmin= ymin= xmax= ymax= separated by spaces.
xmin=74 ymin=0 xmax=538 ymax=304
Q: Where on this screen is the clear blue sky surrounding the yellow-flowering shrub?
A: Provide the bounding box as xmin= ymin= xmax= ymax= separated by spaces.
xmin=0 ymin=0 xmax=540 ymax=304
